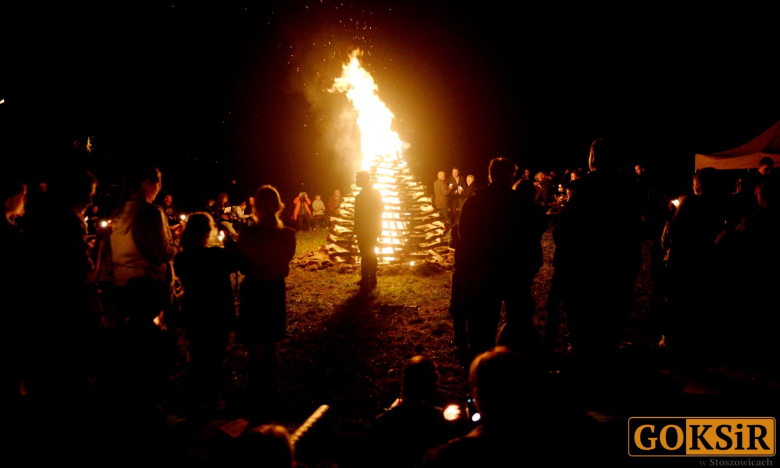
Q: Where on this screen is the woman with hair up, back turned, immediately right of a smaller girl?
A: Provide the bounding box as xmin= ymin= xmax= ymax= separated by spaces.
xmin=236 ymin=185 xmax=295 ymax=419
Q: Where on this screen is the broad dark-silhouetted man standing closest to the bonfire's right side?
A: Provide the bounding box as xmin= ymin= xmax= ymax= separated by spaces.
xmin=456 ymin=158 xmax=547 ymax=354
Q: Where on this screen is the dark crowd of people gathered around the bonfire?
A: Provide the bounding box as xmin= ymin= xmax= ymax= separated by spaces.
xmin=0 ymin=139 xmax=780 ymax=467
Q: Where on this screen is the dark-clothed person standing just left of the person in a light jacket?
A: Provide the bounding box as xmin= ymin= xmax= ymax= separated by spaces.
xmin=24 ymin=167 xmax=103 ymax=460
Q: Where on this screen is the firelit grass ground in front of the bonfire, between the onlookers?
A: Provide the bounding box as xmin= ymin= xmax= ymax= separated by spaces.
xmin=215 ymin=231 xmax=652 ymax=452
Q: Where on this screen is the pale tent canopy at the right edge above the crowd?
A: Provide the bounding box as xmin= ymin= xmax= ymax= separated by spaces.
xmin=695 ymin=121 xmax=780 ymax=170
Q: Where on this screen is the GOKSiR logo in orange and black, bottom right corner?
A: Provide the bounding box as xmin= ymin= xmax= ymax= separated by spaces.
xmin=628 ymin=417 xmax=776 ymax=457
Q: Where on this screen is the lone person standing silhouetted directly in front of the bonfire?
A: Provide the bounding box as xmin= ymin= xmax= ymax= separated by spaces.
xmin=355 ymin=171 xmax=385 ymax=289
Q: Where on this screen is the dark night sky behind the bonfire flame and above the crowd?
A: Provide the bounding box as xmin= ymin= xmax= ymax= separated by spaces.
xmin=0 ymin=0 xmax=780 ymax=209
